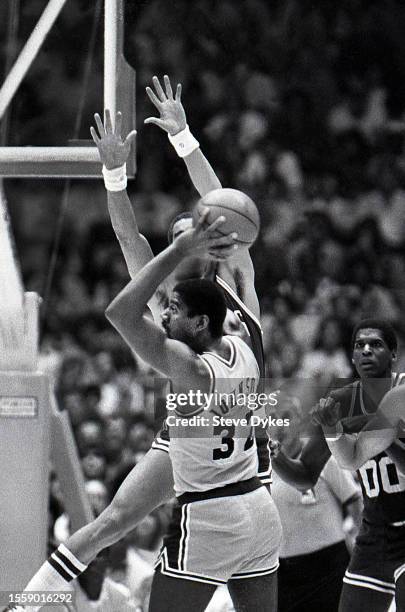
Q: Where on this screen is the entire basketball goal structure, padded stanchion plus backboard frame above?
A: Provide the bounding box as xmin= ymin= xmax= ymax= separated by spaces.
xmin=0 ymin=0 xmax=136 ymax=612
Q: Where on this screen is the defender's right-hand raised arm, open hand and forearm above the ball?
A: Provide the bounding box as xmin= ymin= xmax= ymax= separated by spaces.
xmin=145 ymin=75 xmax=221 ymax=197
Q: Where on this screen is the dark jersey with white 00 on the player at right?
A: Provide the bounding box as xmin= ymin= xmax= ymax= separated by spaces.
xmin=330 ymin=374 xmax=405 ymax=526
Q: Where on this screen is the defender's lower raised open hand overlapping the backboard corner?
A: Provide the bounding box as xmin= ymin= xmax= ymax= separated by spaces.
xmin=90 ymin=110 xmax=136 ymax=170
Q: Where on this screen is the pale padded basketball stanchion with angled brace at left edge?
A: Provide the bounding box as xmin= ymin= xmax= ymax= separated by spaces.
xmin=0 ymin=192 xmax=93 ymax=591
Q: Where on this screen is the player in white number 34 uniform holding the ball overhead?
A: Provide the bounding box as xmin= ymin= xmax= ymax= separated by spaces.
xmin=106 ymin=209 xmax=280 ymax=612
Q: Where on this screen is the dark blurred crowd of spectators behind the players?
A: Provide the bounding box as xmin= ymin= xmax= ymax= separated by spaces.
xmin=0 ymin=0 xmax=405 ymax=604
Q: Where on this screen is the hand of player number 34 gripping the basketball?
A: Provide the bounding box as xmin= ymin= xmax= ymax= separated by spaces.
xmin=173 ymin=208 xmax=238 ymax=260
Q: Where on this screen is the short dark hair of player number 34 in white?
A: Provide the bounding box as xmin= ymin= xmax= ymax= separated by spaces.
xmin=173 ymin=278 xmax=226 ymax=338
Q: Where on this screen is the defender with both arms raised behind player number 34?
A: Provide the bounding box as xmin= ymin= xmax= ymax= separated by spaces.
xmin=13 ymin=76 xmax=277 ymax=612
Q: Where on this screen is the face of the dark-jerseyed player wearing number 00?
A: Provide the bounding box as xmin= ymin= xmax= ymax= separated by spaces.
xmin=353 ymin=329 xmax=394 ymax=378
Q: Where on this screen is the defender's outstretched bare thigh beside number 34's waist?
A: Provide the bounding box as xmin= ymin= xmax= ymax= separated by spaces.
xmin=112 ymin=449 xmax=174 ymax=524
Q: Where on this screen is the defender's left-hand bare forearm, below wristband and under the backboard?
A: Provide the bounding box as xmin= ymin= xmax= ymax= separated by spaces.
xmin=107 ymin=190 xmax=153 ymax=278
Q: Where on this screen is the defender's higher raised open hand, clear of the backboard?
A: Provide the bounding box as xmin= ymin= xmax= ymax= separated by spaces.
xmin=145 ymin=74 xmax=187 ymax=136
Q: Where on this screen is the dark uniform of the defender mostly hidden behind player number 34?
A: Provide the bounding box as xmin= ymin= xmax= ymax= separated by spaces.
xmin=152 ymin=275 xmax=271 ymax=484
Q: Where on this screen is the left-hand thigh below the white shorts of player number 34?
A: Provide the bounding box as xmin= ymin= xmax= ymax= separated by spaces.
xmin=149 ymin=570 xmax=217 ymax=612
